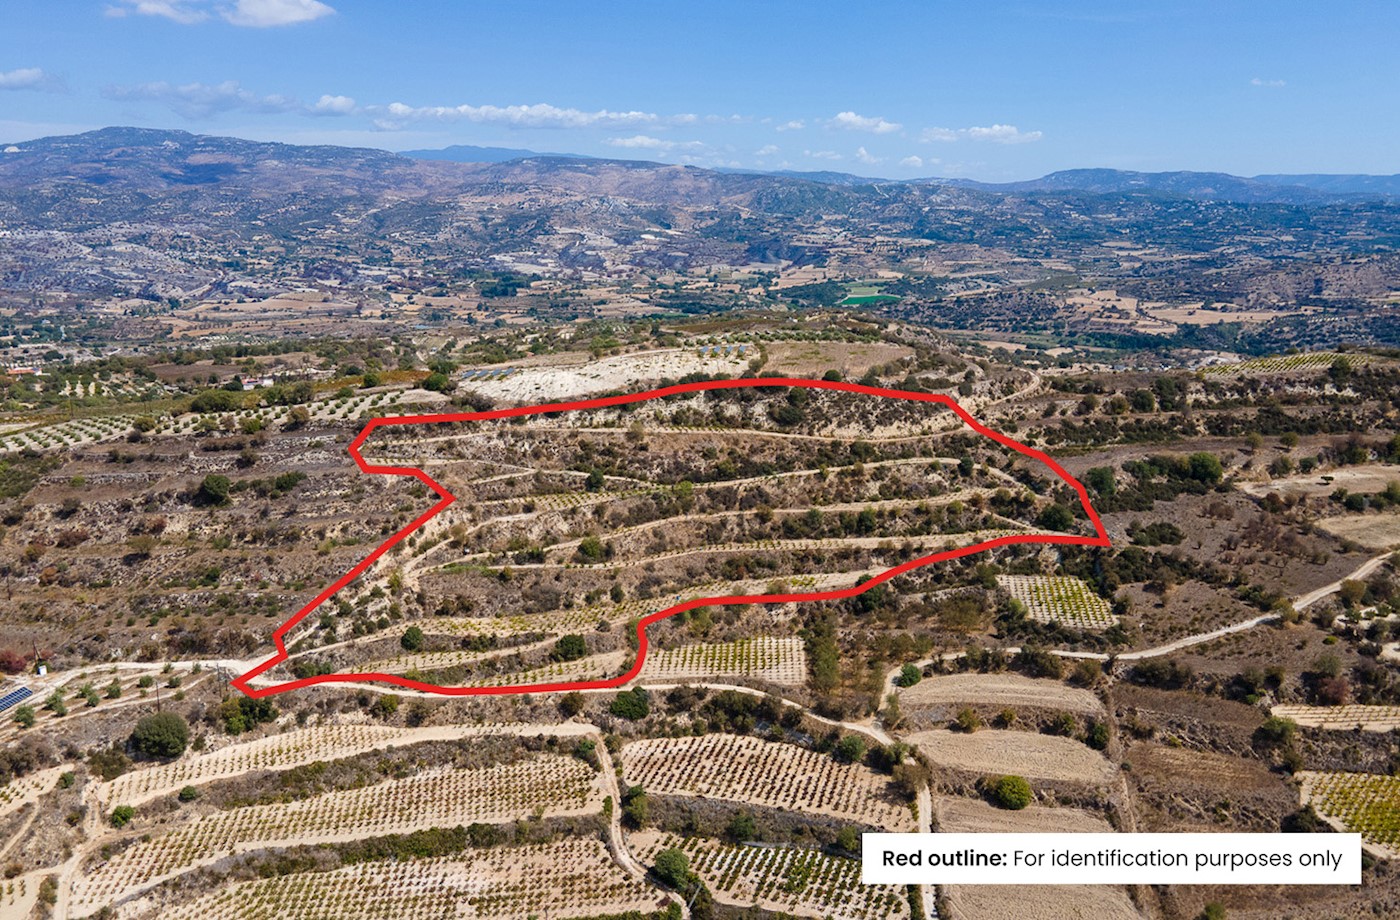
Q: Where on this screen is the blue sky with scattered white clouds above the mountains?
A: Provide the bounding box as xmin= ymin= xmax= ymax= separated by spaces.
xmin=0 ymin=0 xmax=1400 ymax=181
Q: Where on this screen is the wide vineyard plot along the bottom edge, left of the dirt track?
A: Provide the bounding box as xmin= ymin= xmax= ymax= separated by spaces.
xmin=118 ymin=839 xmax=661 ymax=920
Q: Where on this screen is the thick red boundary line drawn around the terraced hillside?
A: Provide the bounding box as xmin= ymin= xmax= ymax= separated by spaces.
xmin=232 ymin=377 xmax=1112 ymax=697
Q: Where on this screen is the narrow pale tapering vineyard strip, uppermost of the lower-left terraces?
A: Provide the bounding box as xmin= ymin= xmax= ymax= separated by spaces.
xmin=97 ymin=725 xmax=435 ymax=805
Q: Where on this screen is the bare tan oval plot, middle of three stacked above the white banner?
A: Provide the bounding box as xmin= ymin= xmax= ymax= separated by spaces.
xmin=906 ymin=728 xmax=1116 ymax=784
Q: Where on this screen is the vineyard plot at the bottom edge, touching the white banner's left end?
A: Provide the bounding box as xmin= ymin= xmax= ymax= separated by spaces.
xmin=627 ymin=832 xmax=909 ymax=920
